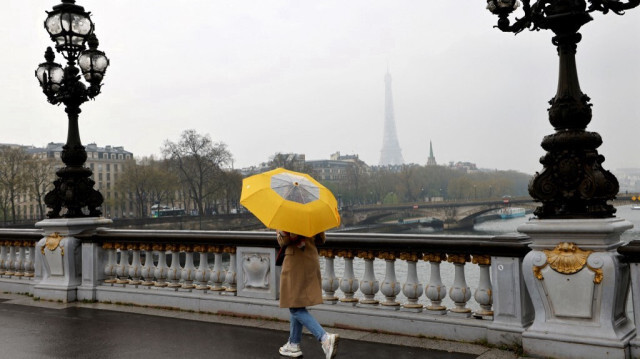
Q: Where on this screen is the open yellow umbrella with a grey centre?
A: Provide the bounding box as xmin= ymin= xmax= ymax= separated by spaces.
xmin=240 ymin=168 xmax=340 ymax=237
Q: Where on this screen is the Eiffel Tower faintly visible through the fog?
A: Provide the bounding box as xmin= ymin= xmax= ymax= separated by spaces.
xmin=379 ymin=70 xmax=404 ymax=166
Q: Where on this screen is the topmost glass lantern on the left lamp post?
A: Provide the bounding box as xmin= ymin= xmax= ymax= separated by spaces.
xmin=44 ymin=0 xmax=93 ymax=60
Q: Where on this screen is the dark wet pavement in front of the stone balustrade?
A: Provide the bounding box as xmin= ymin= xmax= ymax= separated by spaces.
xmin=0 ymin=294 xmax=517 ymax=359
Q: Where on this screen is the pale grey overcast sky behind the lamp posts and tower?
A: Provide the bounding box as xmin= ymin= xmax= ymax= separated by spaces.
xmin=0 ymin=0 xmax=640 ymax=173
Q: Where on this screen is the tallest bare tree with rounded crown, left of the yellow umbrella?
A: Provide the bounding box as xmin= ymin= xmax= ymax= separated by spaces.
xmin=162 ymin=130 xmax=231 ymax=216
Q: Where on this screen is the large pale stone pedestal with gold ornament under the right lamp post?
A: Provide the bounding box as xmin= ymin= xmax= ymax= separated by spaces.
xmin=518 ymin=218 xmax=635 ymax=359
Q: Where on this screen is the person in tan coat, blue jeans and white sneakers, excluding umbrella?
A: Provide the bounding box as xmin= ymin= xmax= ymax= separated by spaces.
xmin=277 ymin=231 xmax=339 ymax=359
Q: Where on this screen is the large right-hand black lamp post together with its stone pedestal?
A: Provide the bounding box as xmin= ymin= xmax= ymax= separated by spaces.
xmin=487 ymin=0 xmax=640 ymax=358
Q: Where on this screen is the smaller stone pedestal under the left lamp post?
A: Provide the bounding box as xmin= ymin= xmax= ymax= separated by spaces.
xmin=33 ymin=217 xmax=112 ymax=302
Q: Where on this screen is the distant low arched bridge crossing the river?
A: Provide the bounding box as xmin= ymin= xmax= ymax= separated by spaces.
xmin=340 ymin=198 xmax=538 ymax=229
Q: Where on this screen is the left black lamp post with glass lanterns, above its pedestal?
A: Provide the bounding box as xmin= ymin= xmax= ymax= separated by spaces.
xmin=36 ymin=0 xmax=109 ymax=218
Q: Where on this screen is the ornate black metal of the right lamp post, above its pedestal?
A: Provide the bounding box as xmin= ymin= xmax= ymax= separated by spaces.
xmin=487 ymin=0 xmax=640 ymax=219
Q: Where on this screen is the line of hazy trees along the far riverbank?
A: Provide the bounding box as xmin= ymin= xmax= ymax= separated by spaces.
xmin=0 ymin=130 xmax=531 ymax=223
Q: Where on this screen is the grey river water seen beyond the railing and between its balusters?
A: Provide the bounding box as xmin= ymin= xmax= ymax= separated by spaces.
xmin=320 ymin=206 xmax=640 ymax=310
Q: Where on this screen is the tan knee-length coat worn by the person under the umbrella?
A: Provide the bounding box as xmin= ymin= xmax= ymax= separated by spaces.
xmin=278 ymin=231 xmax=324 ymax=308
